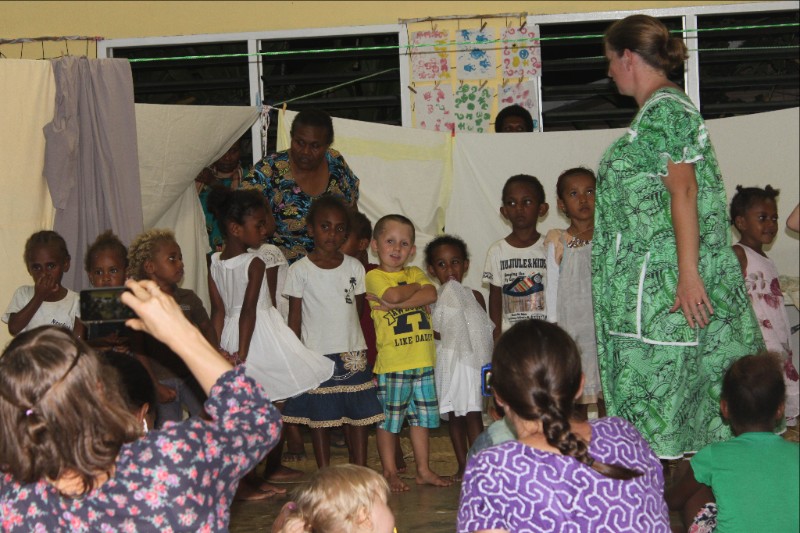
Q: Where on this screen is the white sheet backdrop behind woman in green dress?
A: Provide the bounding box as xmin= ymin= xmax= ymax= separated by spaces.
xmin=446 ymin=108 xmax=800 ymax=294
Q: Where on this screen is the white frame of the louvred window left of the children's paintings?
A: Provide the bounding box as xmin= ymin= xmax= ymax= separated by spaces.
xmin=97 ymin=24 xmax=411 ymax=163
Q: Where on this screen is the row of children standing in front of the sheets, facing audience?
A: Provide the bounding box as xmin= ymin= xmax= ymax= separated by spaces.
xmin=2 ymin=168 xmax=798 ymax=512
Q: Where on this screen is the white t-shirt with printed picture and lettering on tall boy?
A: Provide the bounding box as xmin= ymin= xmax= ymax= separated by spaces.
xmin=483 ymin=237 xmax=547 ymax=331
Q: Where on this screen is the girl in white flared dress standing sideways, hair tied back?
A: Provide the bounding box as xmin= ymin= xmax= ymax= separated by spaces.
xmin=208 ymin=188 xmax=333 ymax=492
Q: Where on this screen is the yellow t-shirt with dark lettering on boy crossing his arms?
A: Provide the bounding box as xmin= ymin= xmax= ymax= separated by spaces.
xmin=366 ymin=267 xmax=436 ymax=374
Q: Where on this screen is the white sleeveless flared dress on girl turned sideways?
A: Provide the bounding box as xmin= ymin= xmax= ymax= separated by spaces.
xmin=211 ymin=246 xmax=333 ymax=401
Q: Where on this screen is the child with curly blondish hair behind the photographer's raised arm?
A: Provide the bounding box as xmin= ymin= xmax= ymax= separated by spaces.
xmin=128 ymin=229 xmax=219 ymax=429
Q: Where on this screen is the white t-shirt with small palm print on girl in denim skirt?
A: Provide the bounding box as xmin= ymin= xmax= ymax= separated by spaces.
xmin=283 ymin=255 xmax=367 ymax=354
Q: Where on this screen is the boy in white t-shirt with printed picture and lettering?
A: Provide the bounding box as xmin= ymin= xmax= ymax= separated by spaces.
xmin=483 ymin=174 xmax=549 ymax=340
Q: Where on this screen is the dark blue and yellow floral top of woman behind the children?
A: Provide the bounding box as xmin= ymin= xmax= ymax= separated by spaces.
xmin=242 ymin=149 xmax=359 ymax=264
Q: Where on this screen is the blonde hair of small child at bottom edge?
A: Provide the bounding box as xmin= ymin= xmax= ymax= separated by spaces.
xmin=294 ymin=464 xmax=390 ymax=533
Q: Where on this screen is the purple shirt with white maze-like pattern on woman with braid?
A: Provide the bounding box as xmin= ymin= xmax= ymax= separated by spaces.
xmin=458 ymin=418 xmax=670 ymax=533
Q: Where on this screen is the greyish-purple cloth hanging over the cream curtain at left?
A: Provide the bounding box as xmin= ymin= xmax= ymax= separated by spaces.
xmin=44 ymin=57 xmax=142 ymax=291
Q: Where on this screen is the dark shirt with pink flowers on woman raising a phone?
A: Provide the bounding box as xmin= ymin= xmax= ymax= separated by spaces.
xmin=0 ymin=366 xmax=280 ymax=533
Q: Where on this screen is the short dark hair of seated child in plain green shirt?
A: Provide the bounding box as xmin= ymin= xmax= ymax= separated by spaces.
xmin=722 ymin=353 xmax=786 ymax=429
